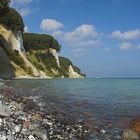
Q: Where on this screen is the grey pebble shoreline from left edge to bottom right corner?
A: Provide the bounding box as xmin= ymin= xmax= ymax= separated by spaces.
xmin=0 ymin=80 xmax=139 ymax=140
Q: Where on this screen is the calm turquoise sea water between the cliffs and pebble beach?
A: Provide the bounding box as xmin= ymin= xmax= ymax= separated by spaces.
xmin=8 ymin=79 xmax=140 ymax=127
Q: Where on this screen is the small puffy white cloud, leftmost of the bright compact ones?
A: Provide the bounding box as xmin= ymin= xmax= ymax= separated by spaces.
xmin=40 ymin=19 xmax=63 ymax=32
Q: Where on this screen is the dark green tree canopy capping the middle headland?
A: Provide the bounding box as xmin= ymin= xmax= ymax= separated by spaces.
xmin=23 ymin=33 xmax=61 ymax=52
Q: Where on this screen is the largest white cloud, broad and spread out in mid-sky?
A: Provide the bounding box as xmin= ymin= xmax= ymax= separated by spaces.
xmin=52 ymin=24 xmax=101 ymax=47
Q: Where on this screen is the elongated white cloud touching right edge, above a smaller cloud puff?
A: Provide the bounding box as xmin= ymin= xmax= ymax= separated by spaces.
xmin=112 ymin=29 xmax=140 ymax=40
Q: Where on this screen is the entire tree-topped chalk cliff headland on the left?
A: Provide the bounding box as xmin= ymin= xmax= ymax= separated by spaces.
xmin=0 ymin=0 xmax=85 ymax=78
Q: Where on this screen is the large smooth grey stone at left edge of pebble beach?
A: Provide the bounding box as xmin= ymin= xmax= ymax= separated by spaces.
xmin=0 ymin=105 xmax=11 ymax=117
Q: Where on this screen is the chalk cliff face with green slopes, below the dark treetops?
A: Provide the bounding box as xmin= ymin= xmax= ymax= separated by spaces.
xmin=0 ymin=24 xmax=84 ymax=78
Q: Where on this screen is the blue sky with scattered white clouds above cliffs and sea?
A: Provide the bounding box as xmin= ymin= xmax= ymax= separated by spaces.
xmin=11 ymin=0 xmax=140 ymax=77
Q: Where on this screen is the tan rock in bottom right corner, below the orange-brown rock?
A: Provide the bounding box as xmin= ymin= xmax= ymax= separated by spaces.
xmin=122 ymin=130 xmax=140 ymax=140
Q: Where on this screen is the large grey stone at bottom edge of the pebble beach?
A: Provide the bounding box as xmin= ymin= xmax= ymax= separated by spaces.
xmin=35 ymin=129 xmax=49 ymax=140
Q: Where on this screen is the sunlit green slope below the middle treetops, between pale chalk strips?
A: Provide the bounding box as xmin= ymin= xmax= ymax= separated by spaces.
xmin=27 ymin=50 xmax=67 ymax=77
